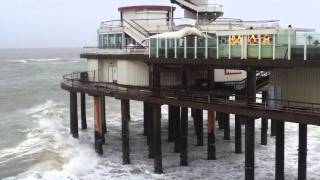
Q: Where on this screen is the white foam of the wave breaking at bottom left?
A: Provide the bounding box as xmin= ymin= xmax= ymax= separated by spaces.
xmin=0 ymin=100 xmax=98 ymax=179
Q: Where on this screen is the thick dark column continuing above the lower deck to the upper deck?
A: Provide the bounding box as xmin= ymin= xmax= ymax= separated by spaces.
xmin=245 ymin=69 xmax=256 ymax=180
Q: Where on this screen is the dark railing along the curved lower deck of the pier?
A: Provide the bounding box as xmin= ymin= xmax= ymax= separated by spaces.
xmin=63 ymin=71 xmax=320 ymax=116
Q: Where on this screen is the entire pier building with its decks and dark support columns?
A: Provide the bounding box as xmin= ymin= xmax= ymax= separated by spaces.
xmin=61 ymin=0 xmax=320 ymax=180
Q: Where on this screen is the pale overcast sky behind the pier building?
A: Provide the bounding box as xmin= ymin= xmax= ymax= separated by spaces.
xmin=0 ymin=0 xmax=320 ymax=48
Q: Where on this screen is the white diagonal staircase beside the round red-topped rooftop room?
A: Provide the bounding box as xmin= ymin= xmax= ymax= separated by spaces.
xmin=122 ymin=19 xmax=149 ymax=47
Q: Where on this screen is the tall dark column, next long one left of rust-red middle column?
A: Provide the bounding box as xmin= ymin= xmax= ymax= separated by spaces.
xmin=180 ymin=107 xmax=188 ymax=166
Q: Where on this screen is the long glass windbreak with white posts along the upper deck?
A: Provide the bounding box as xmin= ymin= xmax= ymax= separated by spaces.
xmin=150 ymin=30 xmax=320 ymax=60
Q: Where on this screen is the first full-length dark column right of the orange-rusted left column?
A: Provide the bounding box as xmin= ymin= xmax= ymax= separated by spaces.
xmin=121 ymin=100 xmax=130 ymax=164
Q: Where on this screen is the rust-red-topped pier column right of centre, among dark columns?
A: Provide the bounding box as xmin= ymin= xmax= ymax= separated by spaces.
xmin=208 ymin=111 xmax=216 ymax=160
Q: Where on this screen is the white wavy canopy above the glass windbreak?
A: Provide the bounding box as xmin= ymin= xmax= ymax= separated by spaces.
xmin=149 ymin=27 xmax=207 ymax=39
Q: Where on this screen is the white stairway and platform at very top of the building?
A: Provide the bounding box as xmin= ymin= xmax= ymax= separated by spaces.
xmin=171 ymin=0 xmax=223 ymax=22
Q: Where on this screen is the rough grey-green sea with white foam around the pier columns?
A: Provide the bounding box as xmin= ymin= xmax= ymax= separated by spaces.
xmin=0 ymin=49 xmax=320 ymax=180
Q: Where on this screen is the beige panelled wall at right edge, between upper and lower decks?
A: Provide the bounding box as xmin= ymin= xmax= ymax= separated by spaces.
xmin=270 ymin=68 xmax=320 ymax=103
